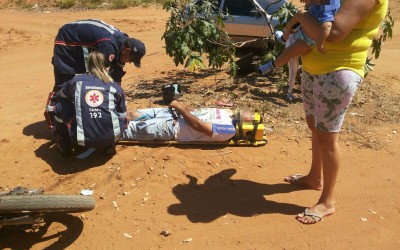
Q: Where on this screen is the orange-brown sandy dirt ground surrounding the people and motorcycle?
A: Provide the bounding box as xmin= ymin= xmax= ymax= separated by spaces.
xmin=0 ymin=0 xmax=400 ymax=249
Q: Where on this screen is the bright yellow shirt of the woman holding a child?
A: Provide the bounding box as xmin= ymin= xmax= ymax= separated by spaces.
xmin=302 ymin=0 xmax=389 ymax=77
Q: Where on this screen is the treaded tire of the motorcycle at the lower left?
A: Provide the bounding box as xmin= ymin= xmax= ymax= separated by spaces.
xmin=0 ymin=194 xmax=96 ymax=214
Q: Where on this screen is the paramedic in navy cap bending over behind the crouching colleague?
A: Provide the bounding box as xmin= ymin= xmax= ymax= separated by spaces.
xmin=52 ymin=19 xmax=146 ymax=92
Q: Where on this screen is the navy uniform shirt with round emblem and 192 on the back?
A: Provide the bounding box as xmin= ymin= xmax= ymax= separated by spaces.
xmin=60 ymin=74 xmax=127 ymax=148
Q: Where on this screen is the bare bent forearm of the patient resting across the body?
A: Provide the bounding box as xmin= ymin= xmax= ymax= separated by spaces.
xmin=169 ymin=101 xmax=212 ymax=136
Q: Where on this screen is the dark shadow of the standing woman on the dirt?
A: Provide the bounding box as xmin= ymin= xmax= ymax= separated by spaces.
xmin=168 ymin=169 xmax=304 ymax=223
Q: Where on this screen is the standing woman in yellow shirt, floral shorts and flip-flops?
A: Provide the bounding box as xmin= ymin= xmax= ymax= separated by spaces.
xmin=285 ymin=0 xmax=388 ymax=224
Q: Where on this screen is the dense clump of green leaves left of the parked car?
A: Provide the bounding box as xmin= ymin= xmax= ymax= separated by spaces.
xmin=162 ymin=0 xmax=237 ymax=76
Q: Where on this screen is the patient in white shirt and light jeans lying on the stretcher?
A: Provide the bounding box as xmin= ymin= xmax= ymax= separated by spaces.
xmin=121 ymin=101 xmax=236 ymax=142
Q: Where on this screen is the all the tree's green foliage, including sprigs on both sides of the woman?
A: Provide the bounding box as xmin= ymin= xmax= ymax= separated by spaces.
xmin=162 ymin=0 xmax=394 ymax=77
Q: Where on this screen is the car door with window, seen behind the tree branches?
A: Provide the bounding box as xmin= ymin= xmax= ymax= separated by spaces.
xmin=220 ymin=0 xmax=271 ymax=41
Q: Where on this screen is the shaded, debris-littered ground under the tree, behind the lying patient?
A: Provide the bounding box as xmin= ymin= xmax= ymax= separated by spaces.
xmin=124 ymin=65 xmax=300 ymax=108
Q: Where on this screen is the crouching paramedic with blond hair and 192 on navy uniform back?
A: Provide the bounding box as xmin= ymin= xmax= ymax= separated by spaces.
xmin=55 ymin=51 xmax=127 ymax=157
